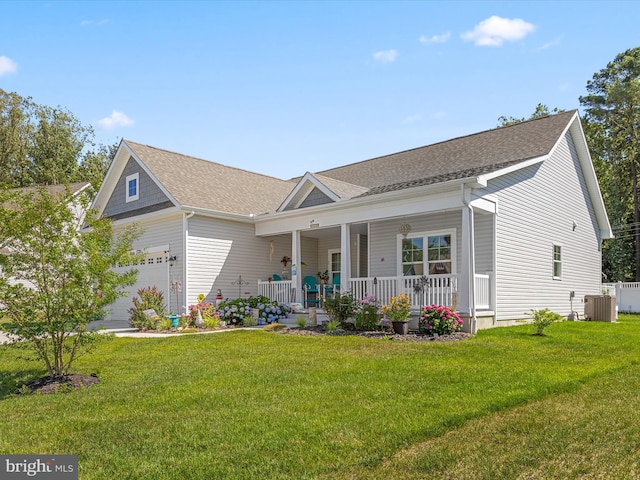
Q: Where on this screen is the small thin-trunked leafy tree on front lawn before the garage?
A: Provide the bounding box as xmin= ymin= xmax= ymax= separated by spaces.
xmin=0 ymin=188 xmax=138 ymax=377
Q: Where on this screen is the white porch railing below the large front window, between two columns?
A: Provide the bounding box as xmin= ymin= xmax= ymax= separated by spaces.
xmin=350 ymin=275 xmax=458 ymax=308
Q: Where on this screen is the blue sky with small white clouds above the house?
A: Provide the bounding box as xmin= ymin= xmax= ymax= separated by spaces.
xmin=0 ymin=0 xmax=640 ymax=180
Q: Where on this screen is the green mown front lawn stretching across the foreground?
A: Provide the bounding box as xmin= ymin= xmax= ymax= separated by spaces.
xmin=0 ymin=316 xmax=640 ymax=479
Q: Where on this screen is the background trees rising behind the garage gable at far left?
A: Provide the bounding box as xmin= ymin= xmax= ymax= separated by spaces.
xmin=0 ymin=89 xmax=115 ymax=191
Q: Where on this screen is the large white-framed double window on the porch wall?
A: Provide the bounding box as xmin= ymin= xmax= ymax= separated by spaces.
xmin=400 ymin=230 xmax=455 ymax=275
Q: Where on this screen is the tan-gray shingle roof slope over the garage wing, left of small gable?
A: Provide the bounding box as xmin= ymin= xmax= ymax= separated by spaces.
xmin=124 ymin=140 xmax=295 ymax=215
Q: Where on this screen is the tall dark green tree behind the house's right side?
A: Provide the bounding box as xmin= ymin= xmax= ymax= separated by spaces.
xmin=580 ymin=47 xmax=640 ymax=281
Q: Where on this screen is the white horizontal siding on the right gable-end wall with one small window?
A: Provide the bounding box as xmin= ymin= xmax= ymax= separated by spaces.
xmin=479 ymin=134 xmax=601 ymax=321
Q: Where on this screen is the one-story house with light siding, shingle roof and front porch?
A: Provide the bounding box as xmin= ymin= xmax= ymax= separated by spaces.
xmin=89 ymin=110 xmax=612 ymax=331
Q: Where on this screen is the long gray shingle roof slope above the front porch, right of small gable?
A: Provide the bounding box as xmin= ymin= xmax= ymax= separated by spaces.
xmin=318 ymin=110 xmax=576 ymax=195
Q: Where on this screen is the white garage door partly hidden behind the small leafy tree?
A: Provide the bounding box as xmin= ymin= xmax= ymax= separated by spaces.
xmin=91 ymin=251 xmax=169 ymax=328
